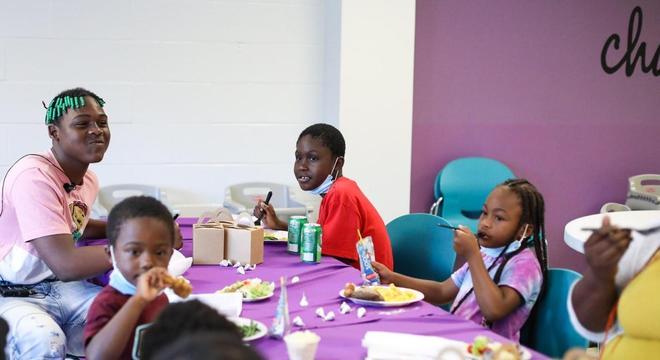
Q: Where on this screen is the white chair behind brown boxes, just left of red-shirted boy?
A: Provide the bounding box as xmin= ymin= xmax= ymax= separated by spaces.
xmin=223 ymin=182 xmax=313 ymax=222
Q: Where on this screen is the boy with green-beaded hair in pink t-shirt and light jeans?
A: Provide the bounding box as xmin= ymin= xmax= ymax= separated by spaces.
xmin=0 ymin=88 xmax=110 ymax=359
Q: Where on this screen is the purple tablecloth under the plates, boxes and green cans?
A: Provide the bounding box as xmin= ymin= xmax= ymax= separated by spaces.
xmin=170 ymin=219 xmax=545 ymax=359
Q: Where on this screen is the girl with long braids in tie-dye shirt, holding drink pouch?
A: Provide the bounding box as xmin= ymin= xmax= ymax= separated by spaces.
xmin=373 ymin=179 xmax=547 ymax=341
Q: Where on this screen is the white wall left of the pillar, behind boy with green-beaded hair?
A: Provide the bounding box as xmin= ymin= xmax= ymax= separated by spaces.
xmin=0 ymin=0 xmax=325 ymax=214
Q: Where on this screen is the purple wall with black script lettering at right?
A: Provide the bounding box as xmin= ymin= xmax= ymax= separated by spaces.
xmin=410 ymin=0 xmax=660 ymax=271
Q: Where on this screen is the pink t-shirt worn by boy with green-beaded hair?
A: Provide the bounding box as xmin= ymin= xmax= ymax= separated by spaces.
xmin=0 ymin=151 xmax=99 ymax=284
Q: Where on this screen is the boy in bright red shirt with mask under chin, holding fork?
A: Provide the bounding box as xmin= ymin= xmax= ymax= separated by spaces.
xmin=254 ymin=124 xmax=394 ymax=269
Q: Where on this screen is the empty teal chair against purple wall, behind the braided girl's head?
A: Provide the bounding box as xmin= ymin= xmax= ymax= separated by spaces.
xmin=431 ymin=157 xmax=515 ymax=232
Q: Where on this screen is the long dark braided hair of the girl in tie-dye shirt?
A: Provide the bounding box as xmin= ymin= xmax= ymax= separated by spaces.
xmin=499 ymin=179 xmax=548 ymax=277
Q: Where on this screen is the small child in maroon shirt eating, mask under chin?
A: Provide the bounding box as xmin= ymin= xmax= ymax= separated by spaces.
xmin=83 ymin=196 xmax=180 ymax=359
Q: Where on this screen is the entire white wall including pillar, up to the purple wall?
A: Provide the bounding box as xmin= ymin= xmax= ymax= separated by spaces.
xmin=0 ymin=0 xmax=415 ymax=221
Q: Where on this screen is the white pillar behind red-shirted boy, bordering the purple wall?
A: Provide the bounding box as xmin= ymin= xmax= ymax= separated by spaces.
xmin=339 ymin=0 xmax=415 ymax=223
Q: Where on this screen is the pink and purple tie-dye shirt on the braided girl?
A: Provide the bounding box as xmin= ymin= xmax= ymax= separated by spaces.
xmin=451 ymin=248 xmax=543 ymax=341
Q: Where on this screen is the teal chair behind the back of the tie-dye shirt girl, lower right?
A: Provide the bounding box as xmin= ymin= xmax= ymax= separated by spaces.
xmin=520 ymin=268 xmax=589 ymax=358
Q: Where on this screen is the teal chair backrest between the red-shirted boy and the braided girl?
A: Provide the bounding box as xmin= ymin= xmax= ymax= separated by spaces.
xmin=387 ymin=214 xmax=456 ymax=281
